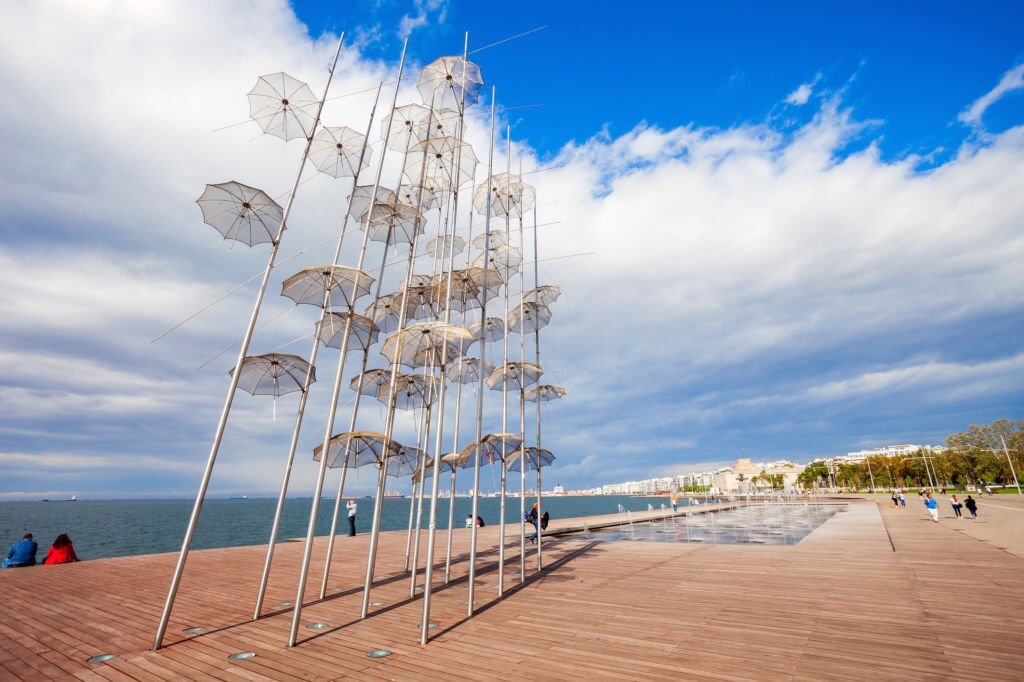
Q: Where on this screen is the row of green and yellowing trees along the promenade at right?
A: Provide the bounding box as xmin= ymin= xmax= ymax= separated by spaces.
xmin=800 ymin=419 xmax=1024 ymax=488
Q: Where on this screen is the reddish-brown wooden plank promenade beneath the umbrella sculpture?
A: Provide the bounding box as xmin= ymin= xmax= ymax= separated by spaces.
xmin=0 ymin=496 xmax=1024 ymax=681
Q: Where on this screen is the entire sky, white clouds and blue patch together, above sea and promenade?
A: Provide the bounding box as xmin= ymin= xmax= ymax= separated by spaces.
xmin=0 ymin=0 xmax=1024 ymax=500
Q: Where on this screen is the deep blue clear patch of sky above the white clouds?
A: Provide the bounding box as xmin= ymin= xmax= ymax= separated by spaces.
xmin=293 ymin=0 xmax=1024 ymax=159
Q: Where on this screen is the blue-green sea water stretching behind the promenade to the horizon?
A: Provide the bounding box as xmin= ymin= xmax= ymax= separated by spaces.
xmin=0 ymin=496 xmax=686 ymax=561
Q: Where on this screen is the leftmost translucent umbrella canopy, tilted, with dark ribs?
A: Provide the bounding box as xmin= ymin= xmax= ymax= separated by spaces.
xmin=196 ymin=180 xmax=285 ymax=246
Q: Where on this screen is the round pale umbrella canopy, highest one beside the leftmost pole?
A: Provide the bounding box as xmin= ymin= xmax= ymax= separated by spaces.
xmin=249 ymin=72 xmax=319 ymax=141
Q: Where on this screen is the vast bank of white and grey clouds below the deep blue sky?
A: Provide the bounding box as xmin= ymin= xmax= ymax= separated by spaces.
xmin=0 ymin=2 xmax=1024 ymax=494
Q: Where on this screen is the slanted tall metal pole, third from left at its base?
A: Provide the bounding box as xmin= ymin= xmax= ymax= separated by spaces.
xmin=288 ymin=39 xmax=409 ymax=647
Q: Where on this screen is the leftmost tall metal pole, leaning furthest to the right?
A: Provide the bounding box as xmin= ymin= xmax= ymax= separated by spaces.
xmin=152 ymin=33 xmax=345 ymax=650
